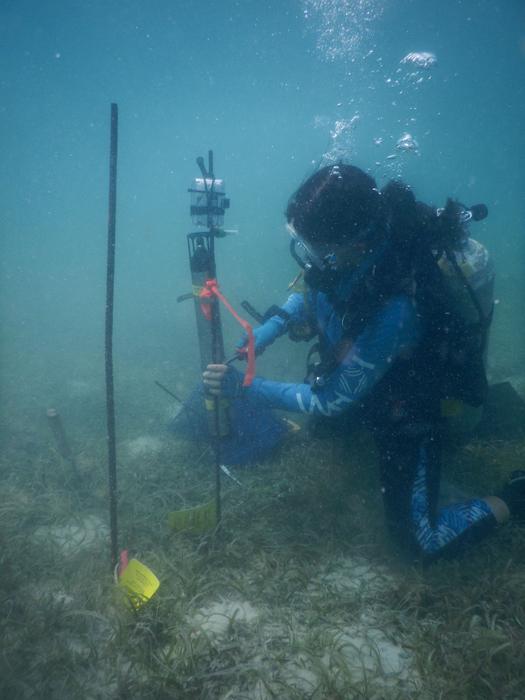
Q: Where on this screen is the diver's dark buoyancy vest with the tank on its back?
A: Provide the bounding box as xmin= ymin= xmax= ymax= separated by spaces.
xmin=307 ymin=238 xmax=494 ymax=424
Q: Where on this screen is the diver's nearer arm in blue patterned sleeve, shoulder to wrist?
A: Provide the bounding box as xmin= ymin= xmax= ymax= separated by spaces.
xmin=244 ymin=297 xmax=419 ymax=416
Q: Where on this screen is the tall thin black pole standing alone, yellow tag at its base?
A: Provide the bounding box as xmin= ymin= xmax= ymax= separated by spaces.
xmin=105 ymin=103 xmax=118 ymax=569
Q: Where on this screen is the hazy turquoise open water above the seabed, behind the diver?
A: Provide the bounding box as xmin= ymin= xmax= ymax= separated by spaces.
xmin=0 ymin=0 xmax=525 ymax=400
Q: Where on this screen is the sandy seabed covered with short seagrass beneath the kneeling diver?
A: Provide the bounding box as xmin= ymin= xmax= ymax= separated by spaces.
xmin=0 ymin=364 xmax=525 ymax=700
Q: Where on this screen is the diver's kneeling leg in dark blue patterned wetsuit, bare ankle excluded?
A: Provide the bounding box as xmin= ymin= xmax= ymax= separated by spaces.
xmin=376 ymin=430 xmax=496 ymax=558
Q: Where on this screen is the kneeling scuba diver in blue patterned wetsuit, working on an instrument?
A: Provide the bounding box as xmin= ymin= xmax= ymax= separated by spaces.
xmin=203 ymin=163 xmax=525 ymax=559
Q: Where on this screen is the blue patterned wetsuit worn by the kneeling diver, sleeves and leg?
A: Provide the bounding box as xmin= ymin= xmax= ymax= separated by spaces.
xmin=239 ymin=292 xmax=496 ymax=557
